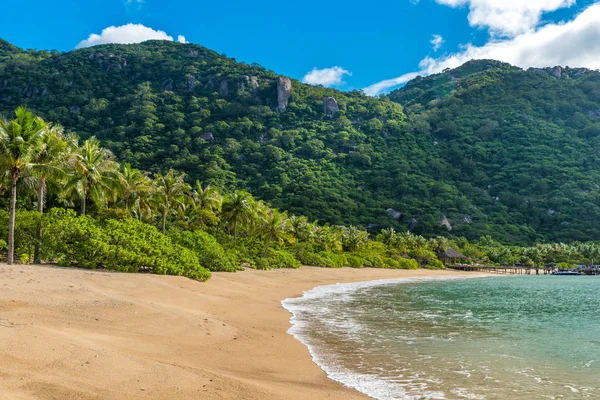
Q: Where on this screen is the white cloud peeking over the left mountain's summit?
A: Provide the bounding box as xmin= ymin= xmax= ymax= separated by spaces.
xmin=75 ymin=23 xmax=187 ymax=49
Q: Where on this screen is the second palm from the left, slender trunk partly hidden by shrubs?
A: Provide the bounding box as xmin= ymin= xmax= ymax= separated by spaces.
xmin=32 ymin=125 xmax=68 ymax=264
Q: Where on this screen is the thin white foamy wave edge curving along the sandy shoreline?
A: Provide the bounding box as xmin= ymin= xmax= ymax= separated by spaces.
xmin=281 ymin=274 xmax=491 ymax=400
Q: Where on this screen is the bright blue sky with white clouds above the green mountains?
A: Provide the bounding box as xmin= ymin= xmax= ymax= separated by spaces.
xmin=0 ymin=0 xmax=600 ymax=94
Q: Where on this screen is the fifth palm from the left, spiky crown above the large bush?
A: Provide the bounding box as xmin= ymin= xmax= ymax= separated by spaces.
xmin=154 ymin=169 xmax=191 ymax=234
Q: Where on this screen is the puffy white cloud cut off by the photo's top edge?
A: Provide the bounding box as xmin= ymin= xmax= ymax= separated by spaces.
xmin=435 ymin=0 xmax=576 ymax=37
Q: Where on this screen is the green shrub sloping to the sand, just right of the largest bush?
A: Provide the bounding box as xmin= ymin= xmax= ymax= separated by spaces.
xmin=169 ymin=230 xmax=240 ymax=272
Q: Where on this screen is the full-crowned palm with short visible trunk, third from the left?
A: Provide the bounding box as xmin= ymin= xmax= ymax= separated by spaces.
xmin=67 ymin=137 xmax=120 ymax=215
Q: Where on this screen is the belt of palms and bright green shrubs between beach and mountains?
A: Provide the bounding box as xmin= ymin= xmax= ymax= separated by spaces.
xmin=0 ymin=106 xmax=600 ymax=280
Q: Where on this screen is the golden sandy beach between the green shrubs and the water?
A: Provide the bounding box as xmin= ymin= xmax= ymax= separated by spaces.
xmin=0 ymin=265 xmax=482 ymax=400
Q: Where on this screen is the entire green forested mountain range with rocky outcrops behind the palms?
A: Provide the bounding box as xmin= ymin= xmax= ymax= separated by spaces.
xmin=0 ymin=41 xmax=600 ymax=243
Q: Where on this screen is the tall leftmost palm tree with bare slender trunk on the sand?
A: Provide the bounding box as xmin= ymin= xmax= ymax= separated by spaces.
xmin=0 ymin=106 xmax=48 ymax=265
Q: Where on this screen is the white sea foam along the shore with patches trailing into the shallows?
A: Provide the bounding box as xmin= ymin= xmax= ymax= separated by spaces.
xmin=281 ymin=275 xmax=486 ymax=400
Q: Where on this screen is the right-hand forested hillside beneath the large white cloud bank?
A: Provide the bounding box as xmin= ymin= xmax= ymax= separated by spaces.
xmin=389 ymin=60 xmax=600 ymax=240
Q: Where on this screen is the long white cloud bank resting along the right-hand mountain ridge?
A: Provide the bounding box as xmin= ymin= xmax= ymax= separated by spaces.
xmin=364 ymin=0 xmax=600 ymax=96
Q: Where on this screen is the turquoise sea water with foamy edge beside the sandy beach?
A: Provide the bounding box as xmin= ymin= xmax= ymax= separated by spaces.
xmin=283 ymin=276 xmax=600 ymax=399
